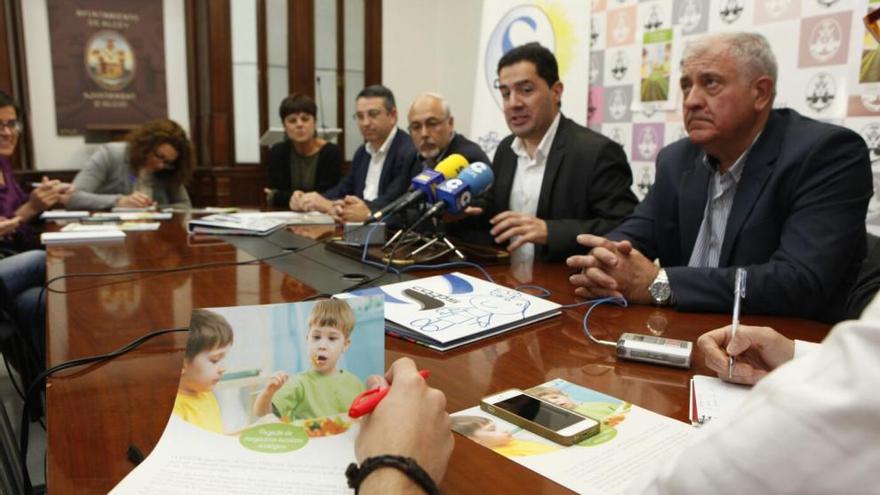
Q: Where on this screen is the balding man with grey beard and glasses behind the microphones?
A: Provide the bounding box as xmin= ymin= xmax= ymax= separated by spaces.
xmin=407 ymin=93 xmax=489 ymax=170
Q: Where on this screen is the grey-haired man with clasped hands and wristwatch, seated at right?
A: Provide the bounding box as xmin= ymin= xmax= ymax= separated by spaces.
xmin=568 ymin=33 xmax=871 ymax=321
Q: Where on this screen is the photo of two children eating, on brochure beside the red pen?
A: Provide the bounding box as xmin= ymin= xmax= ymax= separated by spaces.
xmin=173 ymin=296 xmax=385 ymax=437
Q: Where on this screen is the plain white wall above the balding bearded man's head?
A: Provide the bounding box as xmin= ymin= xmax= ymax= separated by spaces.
xmin=382 ymin=0 xmax=482 ymax=137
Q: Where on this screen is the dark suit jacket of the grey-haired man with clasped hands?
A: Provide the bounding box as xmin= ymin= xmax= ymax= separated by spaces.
xmin=608 ymin=110 xmax=872 ymax=321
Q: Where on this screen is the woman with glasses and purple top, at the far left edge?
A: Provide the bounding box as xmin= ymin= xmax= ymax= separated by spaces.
xmin=0 ymin=91 xmax=69 ymax=252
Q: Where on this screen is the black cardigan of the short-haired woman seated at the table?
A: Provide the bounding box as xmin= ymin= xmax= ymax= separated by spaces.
xmin=266 ymin=139 xmax=342 ymax=207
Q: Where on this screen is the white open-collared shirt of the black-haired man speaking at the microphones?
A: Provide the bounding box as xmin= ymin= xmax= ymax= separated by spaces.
xmin=509 ymin=112 xmax=562 ymax=257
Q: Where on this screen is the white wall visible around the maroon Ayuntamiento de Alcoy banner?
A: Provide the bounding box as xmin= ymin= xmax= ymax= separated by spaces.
xmin=21 ymin=0 xmax=189 ymax=170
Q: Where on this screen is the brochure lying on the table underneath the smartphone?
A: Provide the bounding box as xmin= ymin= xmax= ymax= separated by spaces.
xmin=452 ymin=379 xmax=694 ymax=494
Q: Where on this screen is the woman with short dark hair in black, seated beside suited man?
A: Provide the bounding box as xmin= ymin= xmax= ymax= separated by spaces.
xmin=265 ymin=95 xmax=342 ymax=207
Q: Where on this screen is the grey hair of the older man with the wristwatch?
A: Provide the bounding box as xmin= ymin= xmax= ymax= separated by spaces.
xmin=681 ymin=32 xmax=777 ymax=95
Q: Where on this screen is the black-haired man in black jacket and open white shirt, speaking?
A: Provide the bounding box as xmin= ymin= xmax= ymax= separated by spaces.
xmin=468 ymin=43 xmax=637 ymax=260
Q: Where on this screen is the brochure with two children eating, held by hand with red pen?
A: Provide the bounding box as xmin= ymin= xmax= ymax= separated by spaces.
xmin=111 ymin=297 xmax=385 ymax=495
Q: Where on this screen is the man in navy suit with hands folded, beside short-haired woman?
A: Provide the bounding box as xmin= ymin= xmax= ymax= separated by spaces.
xmin=291 ymin=84 xmax=416 ymax=222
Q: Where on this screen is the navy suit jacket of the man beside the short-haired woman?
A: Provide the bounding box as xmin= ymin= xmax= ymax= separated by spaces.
xmin=324 ymin=129 xmax=417 ymax=211
